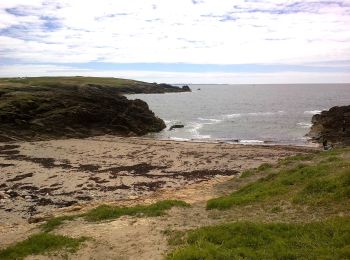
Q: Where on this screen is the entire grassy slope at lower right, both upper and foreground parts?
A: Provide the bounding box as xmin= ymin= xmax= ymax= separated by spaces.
xmin=168 ymin=148 xmax=350 ymax=259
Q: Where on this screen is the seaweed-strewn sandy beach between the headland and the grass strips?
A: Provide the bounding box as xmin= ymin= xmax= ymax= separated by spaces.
xmin=0 ymin=136 xmax=316 ymax=253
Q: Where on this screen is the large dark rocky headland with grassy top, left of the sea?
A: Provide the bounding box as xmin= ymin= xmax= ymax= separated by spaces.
xmin=0 ymin=77 xmax=190 ymax=142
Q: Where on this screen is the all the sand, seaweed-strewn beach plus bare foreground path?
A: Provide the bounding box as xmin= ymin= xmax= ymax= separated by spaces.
xmin=0 ymin=136 xmax=317 ymax=259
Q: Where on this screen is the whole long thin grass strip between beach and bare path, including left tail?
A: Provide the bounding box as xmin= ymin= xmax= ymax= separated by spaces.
xmin=40 ymin=200 xmax=189 ymax=232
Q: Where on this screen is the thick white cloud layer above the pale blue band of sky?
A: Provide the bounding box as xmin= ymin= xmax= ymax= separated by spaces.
xmin=0 ymin=0 xmax=350 ymax=82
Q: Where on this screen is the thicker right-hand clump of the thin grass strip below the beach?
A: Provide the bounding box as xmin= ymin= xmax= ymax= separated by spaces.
xmin=83 ymin=200 xmax=189 ymax=221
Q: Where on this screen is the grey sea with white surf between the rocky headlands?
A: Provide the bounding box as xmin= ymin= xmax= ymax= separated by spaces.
xmin=128 ymin=84 xmax=350 ymax=145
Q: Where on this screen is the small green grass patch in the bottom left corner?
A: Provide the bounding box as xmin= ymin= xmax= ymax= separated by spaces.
xmin=0 ymin=233 xmax=87 ymax=260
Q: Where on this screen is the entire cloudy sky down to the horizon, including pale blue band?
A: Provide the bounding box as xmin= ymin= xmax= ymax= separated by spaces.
xmin=0 ymin=0 xmax=350 ymax=84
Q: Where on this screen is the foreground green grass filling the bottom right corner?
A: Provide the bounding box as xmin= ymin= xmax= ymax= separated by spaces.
xmin=167 ymin=217 xmax=350 ymax=260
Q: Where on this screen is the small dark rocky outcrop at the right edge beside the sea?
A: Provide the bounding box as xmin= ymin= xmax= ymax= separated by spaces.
xmin=308 ymin=105 xmax=350 ymax=146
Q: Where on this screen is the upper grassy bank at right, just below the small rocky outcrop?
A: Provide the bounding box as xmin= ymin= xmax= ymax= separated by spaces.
xmin=207 ymin=149 xmax=350 ymax=210
